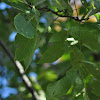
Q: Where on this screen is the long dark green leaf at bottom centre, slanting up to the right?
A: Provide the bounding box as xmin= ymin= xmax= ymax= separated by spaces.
xmin=46 ymin=69 xmax=77 ymax=100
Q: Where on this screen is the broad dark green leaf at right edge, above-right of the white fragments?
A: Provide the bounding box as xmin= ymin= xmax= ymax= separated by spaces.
xmin=69 ymin=23 xmax=100 ymax=50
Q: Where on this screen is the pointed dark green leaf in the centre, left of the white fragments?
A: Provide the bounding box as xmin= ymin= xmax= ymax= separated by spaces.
xmin=39 ymin=42 xmax=64 ymax=63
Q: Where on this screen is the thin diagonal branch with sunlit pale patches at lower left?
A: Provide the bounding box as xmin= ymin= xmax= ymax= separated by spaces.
xmin=0 ymin=39 xmax=38 ymax=100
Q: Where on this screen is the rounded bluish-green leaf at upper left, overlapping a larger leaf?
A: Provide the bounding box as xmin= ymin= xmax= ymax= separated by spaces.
xmin=14 ymin=13 xmax=36 ymax=38
